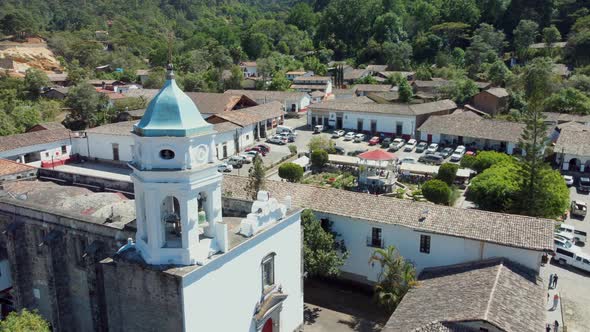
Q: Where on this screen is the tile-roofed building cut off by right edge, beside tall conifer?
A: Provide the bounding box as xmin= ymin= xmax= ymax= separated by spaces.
xmin=553 ymin=122 xmax=590 ymax=172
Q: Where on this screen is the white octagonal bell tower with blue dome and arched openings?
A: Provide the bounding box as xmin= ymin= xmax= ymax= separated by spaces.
xmin=130 ymin=65 xmax=226 ymax=265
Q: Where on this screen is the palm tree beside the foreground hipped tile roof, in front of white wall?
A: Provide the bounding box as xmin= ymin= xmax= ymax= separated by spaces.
xmin=369 ymin=245 xmax=417 ymax=312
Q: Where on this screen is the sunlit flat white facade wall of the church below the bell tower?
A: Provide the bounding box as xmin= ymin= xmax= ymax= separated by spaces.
xmin=182 ymin=214 xmax=303 ymax=332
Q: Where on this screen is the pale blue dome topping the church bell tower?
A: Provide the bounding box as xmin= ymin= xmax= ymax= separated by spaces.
xmin=133 ymin=70 xmax=213 ymax=137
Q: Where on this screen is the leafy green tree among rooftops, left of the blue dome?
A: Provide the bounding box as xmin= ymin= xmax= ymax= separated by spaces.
xmin=66 ymin=83 xmax=107 ymax=129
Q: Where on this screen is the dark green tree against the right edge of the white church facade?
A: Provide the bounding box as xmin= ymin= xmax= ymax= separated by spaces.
xmin=301 ymin=209 xmax=347 ymax=277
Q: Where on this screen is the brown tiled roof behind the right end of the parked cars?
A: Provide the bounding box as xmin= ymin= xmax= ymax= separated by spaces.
xmin=418 ymin=112 xmax=524 ymax=143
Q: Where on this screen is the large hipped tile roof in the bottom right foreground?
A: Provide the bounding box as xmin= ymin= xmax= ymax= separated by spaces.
xmin=382 ymin=258 xmax=546 ymax=332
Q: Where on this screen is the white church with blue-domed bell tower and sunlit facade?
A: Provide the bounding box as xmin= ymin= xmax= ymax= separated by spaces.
xmin=117 ymin=65 xmax=303 ymax=332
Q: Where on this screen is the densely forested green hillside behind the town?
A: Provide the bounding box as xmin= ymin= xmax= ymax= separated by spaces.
xmin=0 ymin=0 xmax=590 ymax=133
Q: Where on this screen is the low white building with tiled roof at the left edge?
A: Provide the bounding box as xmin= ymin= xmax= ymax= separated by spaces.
xmin=0 ymin=128 xmax=76 ymax=167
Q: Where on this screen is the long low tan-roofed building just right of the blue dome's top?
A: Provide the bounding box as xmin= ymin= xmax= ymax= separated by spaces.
xmin=224 ymin=90 xmax=311 ymax=112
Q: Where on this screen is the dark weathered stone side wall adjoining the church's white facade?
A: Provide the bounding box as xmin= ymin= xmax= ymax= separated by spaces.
xmin=101 ymin=256 xmax=184 ymax=332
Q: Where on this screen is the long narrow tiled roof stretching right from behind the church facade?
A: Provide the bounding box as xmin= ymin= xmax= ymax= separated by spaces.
xmin=223 ymin=175 xmax=553 ymax=251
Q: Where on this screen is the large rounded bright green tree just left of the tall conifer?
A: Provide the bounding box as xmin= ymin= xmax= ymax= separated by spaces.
xmin=466 ymin=161 xmax=524 ymax=212
